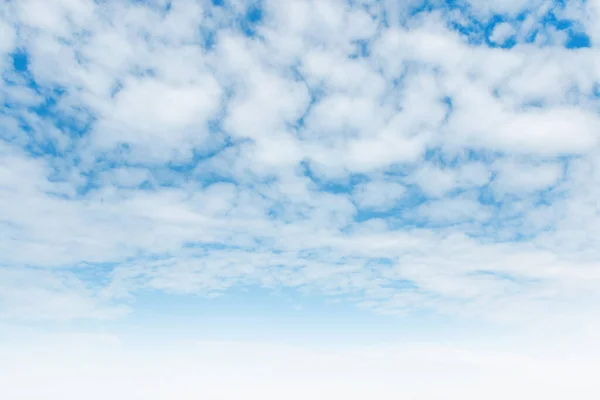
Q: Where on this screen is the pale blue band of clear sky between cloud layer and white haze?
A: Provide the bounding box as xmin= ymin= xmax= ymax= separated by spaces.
xmin=16 ymin=289 xmax=496 ymax=348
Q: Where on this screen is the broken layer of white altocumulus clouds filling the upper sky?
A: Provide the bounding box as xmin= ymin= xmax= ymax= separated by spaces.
xmin=0 ymin=0 xmax=600 ymax=321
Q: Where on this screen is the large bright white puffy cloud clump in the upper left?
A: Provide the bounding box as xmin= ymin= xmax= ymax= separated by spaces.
xmin=92 ymin=77 xmax=221 ymax=161
